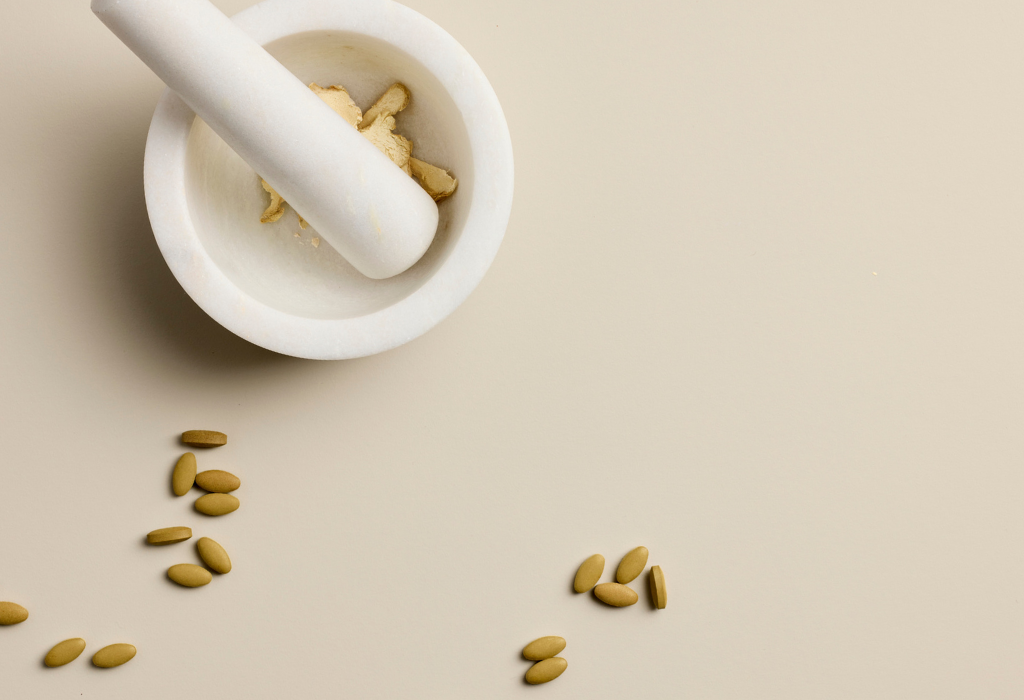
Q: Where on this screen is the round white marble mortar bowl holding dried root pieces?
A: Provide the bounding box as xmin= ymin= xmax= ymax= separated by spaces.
xmin=145 ymin=0 xmax=513 ymax=359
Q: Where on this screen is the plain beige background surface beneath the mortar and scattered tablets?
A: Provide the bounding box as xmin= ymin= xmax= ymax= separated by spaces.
xmin=0 ymin=0 xmax=1024 ymax=700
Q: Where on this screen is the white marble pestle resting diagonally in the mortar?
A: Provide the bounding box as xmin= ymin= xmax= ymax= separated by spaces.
xmin=92 ymin=0 xmax=437 ymax=279
